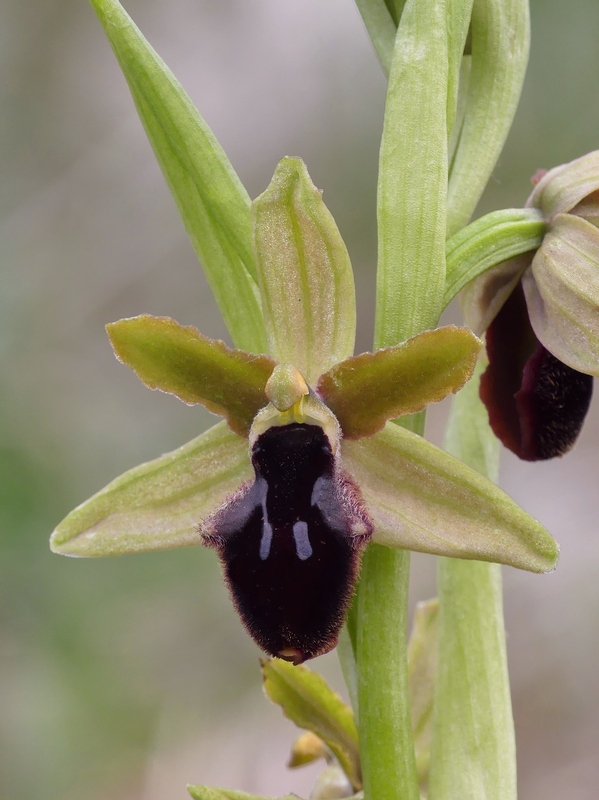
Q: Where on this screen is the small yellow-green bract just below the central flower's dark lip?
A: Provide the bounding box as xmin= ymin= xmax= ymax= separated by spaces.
xmin=261 ymin=658 xmax=362 ymax=790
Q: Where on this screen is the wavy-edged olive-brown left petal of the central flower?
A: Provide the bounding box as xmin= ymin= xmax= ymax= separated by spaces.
xmin=106 ymin=314 xmax=275 ymax=436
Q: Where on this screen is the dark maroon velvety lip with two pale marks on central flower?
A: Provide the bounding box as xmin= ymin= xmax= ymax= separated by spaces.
xmin=204 ymin=423 xmax=372 ymax=664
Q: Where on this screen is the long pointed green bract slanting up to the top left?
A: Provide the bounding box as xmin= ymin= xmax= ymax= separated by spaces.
xmin=91 ymin=0 xmax=266 ymax=353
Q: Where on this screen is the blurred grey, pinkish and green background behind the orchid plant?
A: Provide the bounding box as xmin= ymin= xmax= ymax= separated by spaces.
xmin=0 ymin=0 xmax=599 ymax=800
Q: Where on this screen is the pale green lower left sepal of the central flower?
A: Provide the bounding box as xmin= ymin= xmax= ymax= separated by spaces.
xmin=50 ymin=422 xmax=253 ymax=556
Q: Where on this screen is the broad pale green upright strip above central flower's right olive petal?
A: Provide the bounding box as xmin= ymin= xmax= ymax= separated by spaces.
xmin=374 ymin=0 xmax=448 ymax=348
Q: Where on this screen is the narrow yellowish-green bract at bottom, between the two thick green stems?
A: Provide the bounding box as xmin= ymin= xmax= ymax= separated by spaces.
xmin=408 ymin=599 xmax=439 ymax=795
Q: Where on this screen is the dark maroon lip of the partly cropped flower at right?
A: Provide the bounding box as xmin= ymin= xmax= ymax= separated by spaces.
xmin=480 ymin=285 xmax=593 ymax=461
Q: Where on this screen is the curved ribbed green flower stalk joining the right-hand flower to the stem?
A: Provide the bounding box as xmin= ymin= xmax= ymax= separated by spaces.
xmin=443 ymin=208 xmax=547 ymax=306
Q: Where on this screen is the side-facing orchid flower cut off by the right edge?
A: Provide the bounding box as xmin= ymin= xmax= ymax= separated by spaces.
xmin=463 ymin=151 xmax=599 ymax=461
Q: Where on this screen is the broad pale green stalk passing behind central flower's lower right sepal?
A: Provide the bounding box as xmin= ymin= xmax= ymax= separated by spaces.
xmin=428 ymin=364 xmax=517 ymax=800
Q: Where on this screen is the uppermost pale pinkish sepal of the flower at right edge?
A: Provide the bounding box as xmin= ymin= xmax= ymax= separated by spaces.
xmin=526 ymin=150 xmax=599 ymax=220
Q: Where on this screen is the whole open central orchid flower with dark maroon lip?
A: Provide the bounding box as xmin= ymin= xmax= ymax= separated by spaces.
xmin=51 ymin=158 xmax=557 ymax=663
